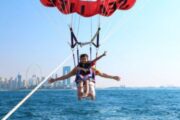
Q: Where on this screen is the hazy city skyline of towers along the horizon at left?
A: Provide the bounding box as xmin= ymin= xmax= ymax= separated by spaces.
xmin=0 ymin=66 xmax=75 ymax=90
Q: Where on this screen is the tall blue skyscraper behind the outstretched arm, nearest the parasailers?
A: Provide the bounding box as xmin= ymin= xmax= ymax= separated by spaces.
xmin=63 ymin=66 xmax=71 ymax=87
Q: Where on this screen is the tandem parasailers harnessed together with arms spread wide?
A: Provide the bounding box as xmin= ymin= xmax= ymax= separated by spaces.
xmin=48 ymin=52 xmax=120 ymax=100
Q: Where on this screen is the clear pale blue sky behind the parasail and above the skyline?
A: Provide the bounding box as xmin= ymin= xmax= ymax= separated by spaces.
xmin=0 ymin=0 xmax=180 ymax=87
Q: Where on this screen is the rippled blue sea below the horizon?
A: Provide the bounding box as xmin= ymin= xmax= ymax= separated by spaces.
xmin=0 ymin=89 xmax=180 ymax=120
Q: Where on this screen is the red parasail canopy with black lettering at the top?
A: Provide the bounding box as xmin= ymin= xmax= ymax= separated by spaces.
xmin=40 ymin=0 xmax=136 ymax=17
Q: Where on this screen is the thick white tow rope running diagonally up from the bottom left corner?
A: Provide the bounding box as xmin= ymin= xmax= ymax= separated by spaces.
xmin=2 ymin=54 xmax=71 ymax=120
